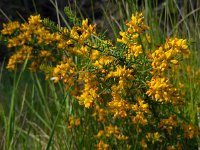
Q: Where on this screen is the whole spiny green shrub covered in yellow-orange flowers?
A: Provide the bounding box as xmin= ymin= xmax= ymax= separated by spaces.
xmin=1 ymin=13 xmax=198 ymax=150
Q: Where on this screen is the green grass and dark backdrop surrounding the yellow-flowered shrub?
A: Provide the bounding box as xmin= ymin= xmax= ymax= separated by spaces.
xmin=0 ymin=0 xmax=200 ymax=149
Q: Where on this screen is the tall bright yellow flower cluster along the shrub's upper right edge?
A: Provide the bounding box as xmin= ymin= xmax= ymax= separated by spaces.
xmin=146 ymin=38 xmax=189 ymax=104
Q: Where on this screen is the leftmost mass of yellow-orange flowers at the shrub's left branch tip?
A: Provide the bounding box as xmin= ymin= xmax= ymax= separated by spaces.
xmin=2 ymin=15 xmax=58 ymax=70
